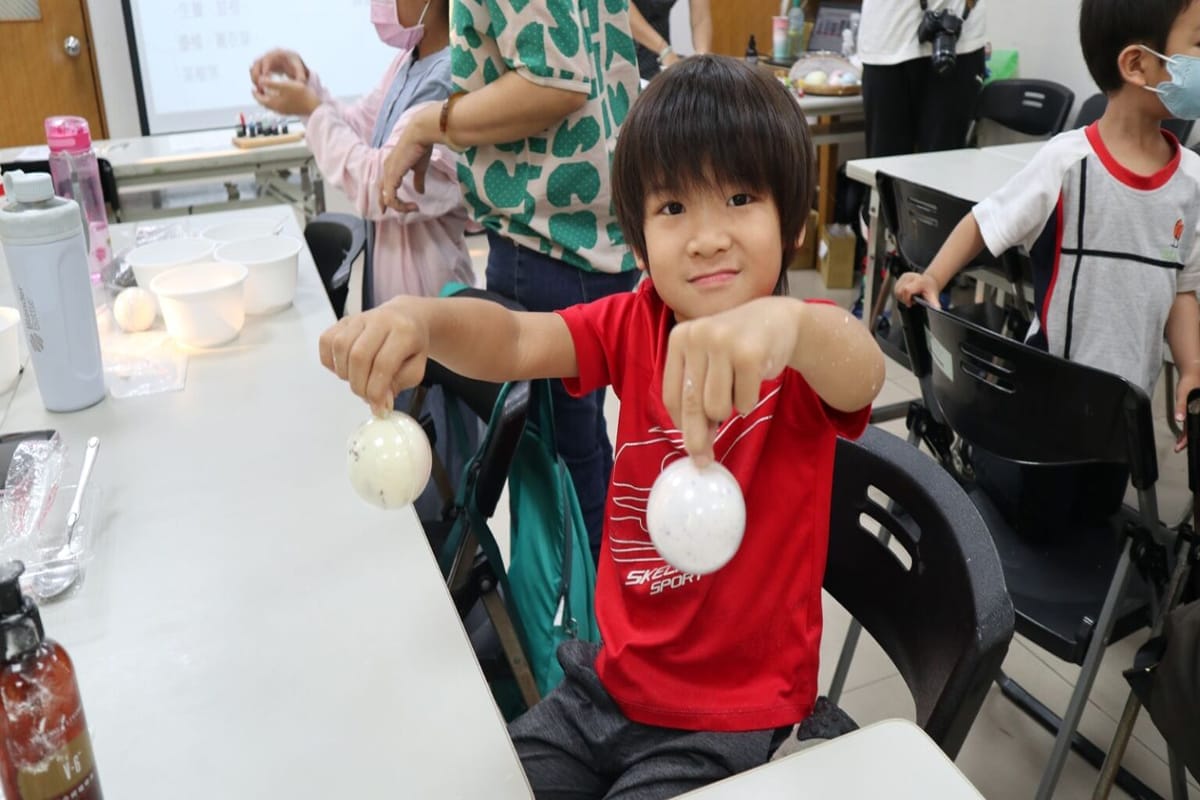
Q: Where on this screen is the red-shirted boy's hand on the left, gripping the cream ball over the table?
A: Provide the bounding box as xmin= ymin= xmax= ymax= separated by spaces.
xmin=319 ymin=296 xmax=430 ymax=414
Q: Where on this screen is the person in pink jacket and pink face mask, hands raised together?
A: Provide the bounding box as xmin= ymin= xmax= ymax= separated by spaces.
xmin=250 ymin=0 xmax=474 ymax=306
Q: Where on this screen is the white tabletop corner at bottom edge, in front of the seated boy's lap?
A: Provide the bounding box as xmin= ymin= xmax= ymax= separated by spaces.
xmin=683 ymin=720 xmax=983 ymax=800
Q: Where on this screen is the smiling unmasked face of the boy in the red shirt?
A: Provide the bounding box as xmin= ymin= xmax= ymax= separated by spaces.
xmin=637 ymin=179 xmax=784 ymax=323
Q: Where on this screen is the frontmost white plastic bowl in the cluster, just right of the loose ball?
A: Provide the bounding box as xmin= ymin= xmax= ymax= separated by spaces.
xmin=150 ymin=261 xmax=246 ymax=347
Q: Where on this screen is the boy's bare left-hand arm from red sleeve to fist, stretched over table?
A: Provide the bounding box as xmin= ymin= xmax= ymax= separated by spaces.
xmin=319 ymin=296 xmax=578 ymax=410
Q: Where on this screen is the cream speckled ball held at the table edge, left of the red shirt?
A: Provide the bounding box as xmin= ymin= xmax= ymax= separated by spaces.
xmin=346 ymin=411 xmax=433 ymax=509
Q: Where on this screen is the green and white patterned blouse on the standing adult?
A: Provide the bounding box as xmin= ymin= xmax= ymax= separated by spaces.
xmin=450 ymin=0 xmax=638 ymax=272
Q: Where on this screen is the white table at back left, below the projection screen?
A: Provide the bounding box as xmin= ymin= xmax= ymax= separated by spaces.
xmin=0 ymin=122 xmax=325 ymax=219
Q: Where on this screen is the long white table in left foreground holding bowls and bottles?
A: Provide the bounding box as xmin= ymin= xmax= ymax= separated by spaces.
xmin=0 ymin=208 xmax=529 ymax=800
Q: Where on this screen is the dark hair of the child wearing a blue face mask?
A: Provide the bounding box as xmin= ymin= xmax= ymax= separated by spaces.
xmin=1079 ymin=0 xmax=1192 ymax=92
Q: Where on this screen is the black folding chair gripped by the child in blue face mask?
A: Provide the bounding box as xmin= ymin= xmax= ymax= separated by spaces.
xmin=901 ymin=302 xmax=1175 ymax=798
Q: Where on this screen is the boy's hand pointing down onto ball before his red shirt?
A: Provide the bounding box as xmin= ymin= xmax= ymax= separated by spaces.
xmin=662 ymin=297 xmax=805 ymax=463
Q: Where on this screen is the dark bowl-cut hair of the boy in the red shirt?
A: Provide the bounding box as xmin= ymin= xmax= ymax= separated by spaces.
xmin=612 ymin=55 xmax=816 ymax=294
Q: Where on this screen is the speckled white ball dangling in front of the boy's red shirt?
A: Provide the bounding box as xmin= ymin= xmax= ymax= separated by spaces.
xmin=646 ymin=458 xmax=746 ymax=575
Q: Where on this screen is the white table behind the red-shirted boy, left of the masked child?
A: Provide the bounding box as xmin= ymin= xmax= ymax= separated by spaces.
xmin=846 ymin=142 xmax=1043 ymax=329
